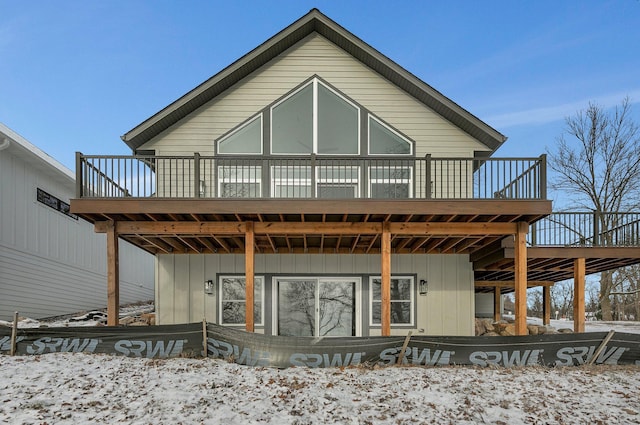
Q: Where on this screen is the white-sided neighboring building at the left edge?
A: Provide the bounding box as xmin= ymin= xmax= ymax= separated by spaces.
xmin=0 ymin=124 xmax=154 ymax=320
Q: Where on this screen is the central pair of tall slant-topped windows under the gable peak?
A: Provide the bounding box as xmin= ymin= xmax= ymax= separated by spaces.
xmin=271 ymin=78 xmax=360 ymax=155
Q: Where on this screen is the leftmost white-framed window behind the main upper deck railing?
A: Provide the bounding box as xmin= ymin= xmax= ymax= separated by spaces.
xmin=218 ymin=165 xmax=262 ymax=198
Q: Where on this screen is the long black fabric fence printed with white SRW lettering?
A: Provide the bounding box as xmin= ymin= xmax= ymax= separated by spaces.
xmin=0 ymin=323 xmax=640 ymax=368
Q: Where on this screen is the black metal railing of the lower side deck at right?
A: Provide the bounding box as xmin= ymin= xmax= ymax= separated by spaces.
xmin=529 ymin=212 xmax=640 ymax=247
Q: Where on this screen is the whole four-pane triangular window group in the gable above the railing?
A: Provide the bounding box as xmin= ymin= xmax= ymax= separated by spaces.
xmin=216 ymin=77 xmax=415 ymax=157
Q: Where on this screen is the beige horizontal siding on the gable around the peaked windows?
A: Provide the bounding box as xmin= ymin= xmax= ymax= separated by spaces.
xmin=140 ymin=34 xmax=489 ymax=158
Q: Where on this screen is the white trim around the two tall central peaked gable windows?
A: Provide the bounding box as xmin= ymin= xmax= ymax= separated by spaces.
xmin=269 ymin=76 xmax=362 ymax=157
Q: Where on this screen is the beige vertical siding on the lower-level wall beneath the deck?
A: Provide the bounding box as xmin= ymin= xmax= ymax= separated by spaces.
xmin=156 ymin=254 xmax=475 ymax=335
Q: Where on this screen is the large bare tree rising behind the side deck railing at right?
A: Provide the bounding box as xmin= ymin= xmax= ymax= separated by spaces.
xmin=547 ymin=98 xmax=640 ymax=320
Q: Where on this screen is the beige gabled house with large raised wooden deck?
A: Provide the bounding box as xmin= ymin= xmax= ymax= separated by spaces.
xmin=71 ymin=9 xmax=640 ymax=336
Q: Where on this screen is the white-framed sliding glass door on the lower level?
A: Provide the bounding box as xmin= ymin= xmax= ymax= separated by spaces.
xmin=275 ymin=277 xmax=360 ymax=336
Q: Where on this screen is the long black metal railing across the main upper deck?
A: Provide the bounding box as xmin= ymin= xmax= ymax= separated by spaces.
xmin=76 ymin=153 xmax=547 ymax=200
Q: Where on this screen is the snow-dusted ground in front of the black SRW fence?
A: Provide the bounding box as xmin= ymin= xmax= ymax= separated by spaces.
xmin=0 ymin=353 xmax=640 ymax=424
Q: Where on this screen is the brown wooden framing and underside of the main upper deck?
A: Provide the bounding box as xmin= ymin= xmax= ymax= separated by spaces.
xmin=72 ymin=198 xmax=551 ymax=255
